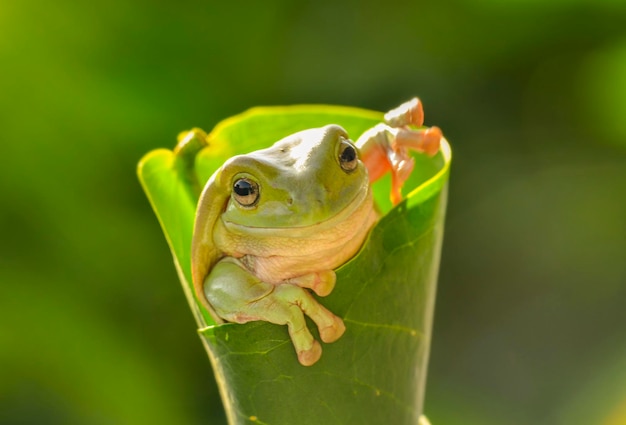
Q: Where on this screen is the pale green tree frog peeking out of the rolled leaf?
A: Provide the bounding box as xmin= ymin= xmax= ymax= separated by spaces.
xmin=191 ymin=98 xmax=443 ymax=366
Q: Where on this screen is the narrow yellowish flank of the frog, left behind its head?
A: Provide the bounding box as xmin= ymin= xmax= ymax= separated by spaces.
xmin=191 ymin=169 xmax=230 ymax=323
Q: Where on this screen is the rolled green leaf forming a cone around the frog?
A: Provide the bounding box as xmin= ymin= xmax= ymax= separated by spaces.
xmin=139 ymin=106 xmax=450 ymax=425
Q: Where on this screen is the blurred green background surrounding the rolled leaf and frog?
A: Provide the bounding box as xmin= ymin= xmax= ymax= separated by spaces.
xmin=0 ymin=0 xmax=626 ymax=425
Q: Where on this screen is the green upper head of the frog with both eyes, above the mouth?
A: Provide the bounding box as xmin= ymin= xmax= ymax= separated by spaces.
xmin=215 ymin=125 xmax=369 ymax=228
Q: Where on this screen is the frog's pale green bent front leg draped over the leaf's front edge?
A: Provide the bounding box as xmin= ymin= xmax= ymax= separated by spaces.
xmin=204 ymin=258 xmax=345 ymax=366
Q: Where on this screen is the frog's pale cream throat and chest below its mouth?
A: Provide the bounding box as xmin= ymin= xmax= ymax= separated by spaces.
xmin=214 ymin=189 xmax=378 ymax=284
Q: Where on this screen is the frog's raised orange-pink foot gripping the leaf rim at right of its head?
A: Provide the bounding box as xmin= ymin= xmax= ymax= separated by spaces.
xmin=356 ymin=98 xmax=443 ymax=205
